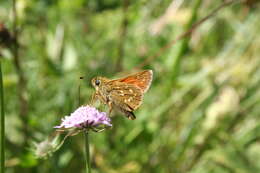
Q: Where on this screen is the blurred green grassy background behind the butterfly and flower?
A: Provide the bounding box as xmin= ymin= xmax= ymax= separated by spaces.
xmin=0 ymin=0 xmax=260 ymax=173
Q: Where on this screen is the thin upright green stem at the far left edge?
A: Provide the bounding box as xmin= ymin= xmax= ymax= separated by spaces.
xmin=0 ymin=60 xmax=5 ymax=173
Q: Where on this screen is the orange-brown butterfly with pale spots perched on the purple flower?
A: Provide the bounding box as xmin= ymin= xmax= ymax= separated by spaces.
xmin=91 ymin=70 xmax=153 ymax=120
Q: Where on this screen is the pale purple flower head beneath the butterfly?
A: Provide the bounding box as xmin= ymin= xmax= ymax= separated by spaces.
xmin=54 ymin=106 xmax=112 ymax=128
